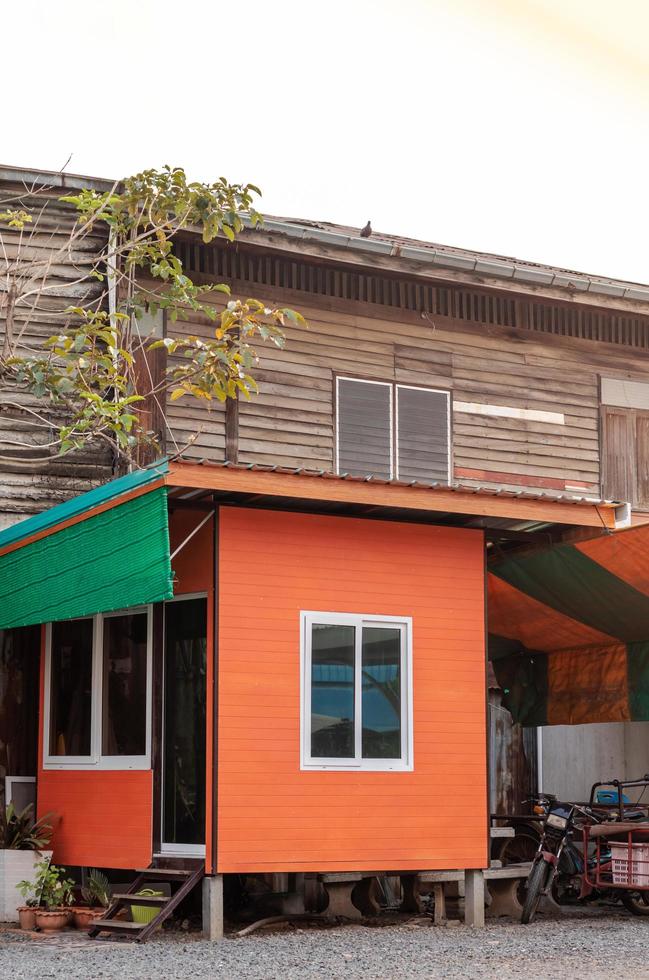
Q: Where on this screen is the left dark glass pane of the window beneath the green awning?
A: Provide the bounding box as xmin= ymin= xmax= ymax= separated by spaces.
xmin=50 ymin=619 xmax=92 ymax=755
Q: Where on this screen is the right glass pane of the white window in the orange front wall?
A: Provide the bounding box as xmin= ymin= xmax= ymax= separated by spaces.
xmin=361 ymin=626 xmax=401 ymax=759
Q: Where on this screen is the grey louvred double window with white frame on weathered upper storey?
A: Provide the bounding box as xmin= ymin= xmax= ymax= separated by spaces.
xmin=336 ymin=377 xmax=450 ymax=483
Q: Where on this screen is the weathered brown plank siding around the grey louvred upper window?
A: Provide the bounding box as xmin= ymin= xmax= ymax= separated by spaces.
xmin=169 ymin=256 xmax=649 ymax=495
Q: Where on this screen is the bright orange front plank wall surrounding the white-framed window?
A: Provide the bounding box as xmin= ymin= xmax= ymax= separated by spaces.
xmin=217 ymin=507 xmax=488 ymax=872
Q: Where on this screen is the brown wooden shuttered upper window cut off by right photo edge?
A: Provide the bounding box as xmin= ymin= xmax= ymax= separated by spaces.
xmin=601 ymin=378 xmax=649 ymax=510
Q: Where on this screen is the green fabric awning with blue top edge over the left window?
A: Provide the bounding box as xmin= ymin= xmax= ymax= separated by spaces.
xmin=0 ymin=462 xmax=173 ymax=629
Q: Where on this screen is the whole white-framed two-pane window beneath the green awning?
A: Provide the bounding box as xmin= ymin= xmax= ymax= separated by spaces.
xmin=43 ymin=607 xmax=151 ymax=769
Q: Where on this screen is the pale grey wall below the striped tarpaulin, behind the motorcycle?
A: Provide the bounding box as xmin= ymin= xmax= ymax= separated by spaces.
xmin=541 ymin=721 xmax=649 ymax=801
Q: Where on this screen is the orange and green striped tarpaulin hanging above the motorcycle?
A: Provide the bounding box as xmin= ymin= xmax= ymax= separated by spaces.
xmin=488 ymin=524 xmax=649 ymax=725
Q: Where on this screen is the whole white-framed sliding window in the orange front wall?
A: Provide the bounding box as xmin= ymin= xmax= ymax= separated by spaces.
xmin=301 ymin=612 xmax=412 ymax=771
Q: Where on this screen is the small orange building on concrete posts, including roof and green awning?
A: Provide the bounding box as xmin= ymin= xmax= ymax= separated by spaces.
xmin=0 ymin=463 xmax=615 ymax=934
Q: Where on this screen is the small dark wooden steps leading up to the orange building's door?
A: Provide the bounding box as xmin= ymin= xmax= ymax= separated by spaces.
xmin=88 ymin=861 xmax=205 ymax=943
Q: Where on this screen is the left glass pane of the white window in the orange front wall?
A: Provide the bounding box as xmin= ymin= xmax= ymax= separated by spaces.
xmin=311 ymin=624 xmax=356 ymax=759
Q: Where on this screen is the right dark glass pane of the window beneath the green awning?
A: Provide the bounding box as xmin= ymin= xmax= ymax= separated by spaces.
xmin=101 ymin=613 xmax=148 ymax=755
